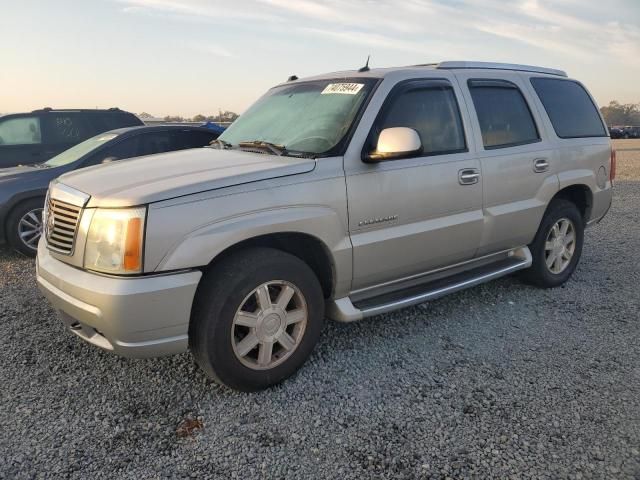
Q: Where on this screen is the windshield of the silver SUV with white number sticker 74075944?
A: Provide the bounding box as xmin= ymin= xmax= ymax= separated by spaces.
xmin=219 ymin=78 xmax=375 ymax=154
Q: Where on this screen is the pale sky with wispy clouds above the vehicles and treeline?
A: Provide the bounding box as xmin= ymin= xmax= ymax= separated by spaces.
xmin=0 ymin=0 xmax=640 ymax=117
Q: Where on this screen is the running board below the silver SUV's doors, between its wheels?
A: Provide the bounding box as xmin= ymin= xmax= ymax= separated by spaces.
xmin=327 ymin=247 xmax=531 ymax=322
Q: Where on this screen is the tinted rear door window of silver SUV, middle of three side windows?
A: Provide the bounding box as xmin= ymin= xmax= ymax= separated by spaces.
xmin=469 ymin=80 xmax=540 ymax=149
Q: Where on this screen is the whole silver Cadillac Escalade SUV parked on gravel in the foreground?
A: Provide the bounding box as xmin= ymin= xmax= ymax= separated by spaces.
xmin=37 ymin=62 xmax=615 ymax=391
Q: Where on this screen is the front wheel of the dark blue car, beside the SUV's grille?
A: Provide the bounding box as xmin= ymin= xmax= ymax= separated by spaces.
xmin=6 ymin=198 xmax=44 ymax=257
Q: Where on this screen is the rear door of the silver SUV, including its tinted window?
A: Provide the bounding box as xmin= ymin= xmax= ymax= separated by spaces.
xmin=456 ymin=70 xmax=558 ymax=255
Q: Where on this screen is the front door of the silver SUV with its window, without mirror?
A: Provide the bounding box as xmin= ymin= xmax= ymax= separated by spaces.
xmin=345 ymin=79 xmax=483 ymax=290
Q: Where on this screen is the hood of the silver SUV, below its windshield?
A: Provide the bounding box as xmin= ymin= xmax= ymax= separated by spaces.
xmin=59 ymin=148 xmax=315 ymax=207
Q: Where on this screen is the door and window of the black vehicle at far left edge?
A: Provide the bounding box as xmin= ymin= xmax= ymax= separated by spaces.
xmin=0 ymin=115 xmax=45 ymax=168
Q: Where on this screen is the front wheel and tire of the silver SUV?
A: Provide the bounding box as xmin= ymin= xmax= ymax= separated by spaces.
xmin=189 ymin=248 xmax=324 ymax=392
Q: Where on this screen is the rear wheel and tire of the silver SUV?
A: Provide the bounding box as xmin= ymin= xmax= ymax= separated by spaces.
xmin=522 ymin=199 xmax=584 ymax=288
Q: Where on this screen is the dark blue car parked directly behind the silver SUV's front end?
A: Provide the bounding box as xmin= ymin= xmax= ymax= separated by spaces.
xmin=0 ymin=125 xmax=218 ymax=256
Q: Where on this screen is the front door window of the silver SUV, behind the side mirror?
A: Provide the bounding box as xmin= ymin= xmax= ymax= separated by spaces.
xmin=379 ymin=86 xmax=466 ymax=155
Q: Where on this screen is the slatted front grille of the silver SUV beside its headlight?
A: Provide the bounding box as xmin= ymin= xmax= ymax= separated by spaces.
xmin=45 ymin=198 xmax=82 ymax=255
